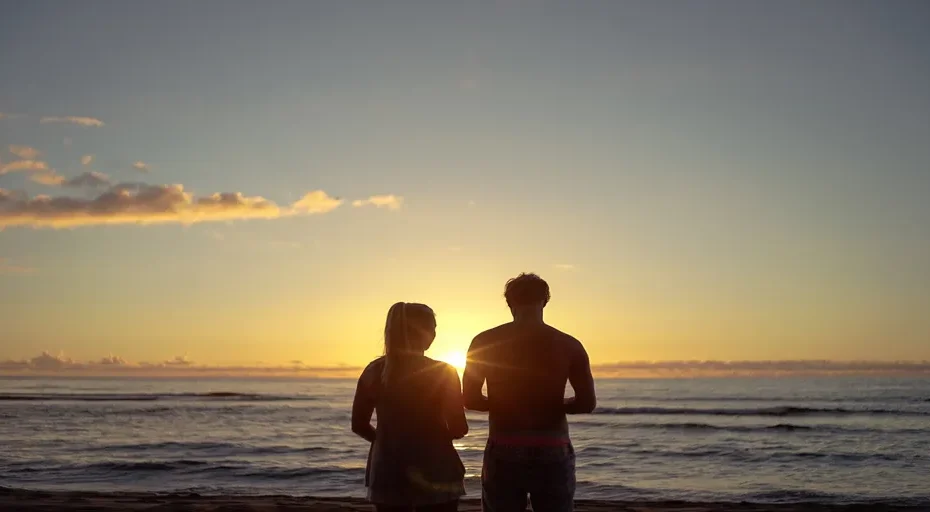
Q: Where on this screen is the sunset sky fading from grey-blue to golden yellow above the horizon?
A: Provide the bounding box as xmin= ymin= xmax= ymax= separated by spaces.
xmin=0 ymin=0 xmax=930 ymax=376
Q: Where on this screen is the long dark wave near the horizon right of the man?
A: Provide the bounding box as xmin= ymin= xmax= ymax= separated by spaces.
xmin=594 ymin=406 xmax=930 ymax=417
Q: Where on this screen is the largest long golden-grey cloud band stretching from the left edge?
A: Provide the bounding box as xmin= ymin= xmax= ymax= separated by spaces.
xmin=0 ymin=181 xmax=358 ymax=229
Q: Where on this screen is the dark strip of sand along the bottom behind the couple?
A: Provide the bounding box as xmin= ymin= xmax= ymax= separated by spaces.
xmin=0 ymin=488 xmax=926 ymax=512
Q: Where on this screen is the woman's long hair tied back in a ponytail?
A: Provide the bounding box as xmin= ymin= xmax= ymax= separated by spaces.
xmin=381 ymin=302 xmax=436 ymax=384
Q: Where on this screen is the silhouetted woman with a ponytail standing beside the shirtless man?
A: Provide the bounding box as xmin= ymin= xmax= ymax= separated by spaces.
xmin=352 ymin=302 xmax=468 ymax=512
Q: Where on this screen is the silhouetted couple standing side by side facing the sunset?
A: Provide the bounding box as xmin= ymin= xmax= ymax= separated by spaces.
xmin=352 ymin=274 xmax=595 ymax=512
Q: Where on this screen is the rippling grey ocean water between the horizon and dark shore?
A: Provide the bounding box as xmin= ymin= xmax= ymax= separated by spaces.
xmin=0 ymin=377 xmax=930 ymax=507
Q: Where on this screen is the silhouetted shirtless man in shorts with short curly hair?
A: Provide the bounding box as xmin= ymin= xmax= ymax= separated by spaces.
xmin=462 ymin=274 xmax=596 ymax=512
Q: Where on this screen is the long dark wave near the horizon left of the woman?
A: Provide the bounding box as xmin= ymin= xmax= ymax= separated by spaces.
xmin=0 ymin=391 xmax=319 ymax=402
